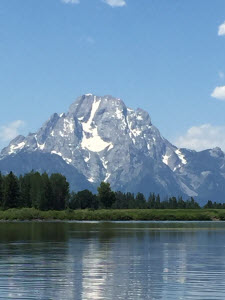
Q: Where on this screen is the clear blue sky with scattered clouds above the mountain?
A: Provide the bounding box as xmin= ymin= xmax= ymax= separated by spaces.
xmin=0 ymin=0 xmax=225 ymax=150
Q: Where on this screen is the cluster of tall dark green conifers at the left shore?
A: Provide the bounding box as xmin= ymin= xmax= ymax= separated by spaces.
xmin=0 ymin=171 xmax=69 ymax=210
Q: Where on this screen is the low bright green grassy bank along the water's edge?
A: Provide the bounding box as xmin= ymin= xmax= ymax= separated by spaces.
xmin=0 ymin=208 xmax=225 ymax=221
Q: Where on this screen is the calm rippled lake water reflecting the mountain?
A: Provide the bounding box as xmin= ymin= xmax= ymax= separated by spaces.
xmin=0 ymin=222 xmax=225 ymax=300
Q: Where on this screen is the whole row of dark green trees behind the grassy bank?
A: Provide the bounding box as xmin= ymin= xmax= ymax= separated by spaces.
xmin=0 ymin=171 xmax=225 ymax=210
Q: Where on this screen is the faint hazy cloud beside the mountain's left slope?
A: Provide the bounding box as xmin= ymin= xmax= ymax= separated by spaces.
xmin=0 ymin=120 xmax=25 ymax=142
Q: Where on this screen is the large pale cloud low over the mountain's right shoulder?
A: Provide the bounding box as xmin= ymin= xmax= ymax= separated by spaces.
xmin=174 ymin=124 xmax=225 ymax=151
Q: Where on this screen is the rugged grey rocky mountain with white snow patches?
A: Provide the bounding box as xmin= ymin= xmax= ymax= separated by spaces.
xmin=0 ymin=94 xmax=225 ymax=202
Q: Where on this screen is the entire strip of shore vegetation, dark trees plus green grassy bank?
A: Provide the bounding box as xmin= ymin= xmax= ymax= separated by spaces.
xmin=0 ymin=171 xmax=225 ymax=221
